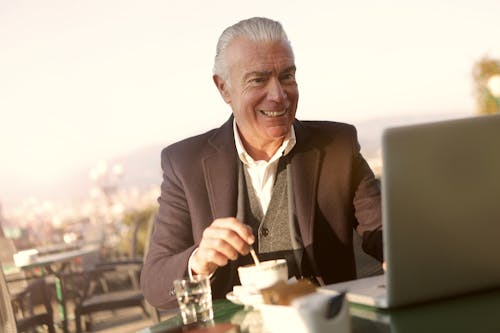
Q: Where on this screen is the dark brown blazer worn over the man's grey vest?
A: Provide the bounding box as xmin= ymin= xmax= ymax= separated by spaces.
xmin=141 ymin=117 xmax=382 ymax=308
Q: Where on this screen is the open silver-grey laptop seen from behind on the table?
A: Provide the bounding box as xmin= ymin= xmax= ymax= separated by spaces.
xmin=323 ymin=115 xmax=500 ymax=308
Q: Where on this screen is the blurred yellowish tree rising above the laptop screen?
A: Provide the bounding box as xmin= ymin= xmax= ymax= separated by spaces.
xmin=472 ymin=56 xmax=500 ymax=114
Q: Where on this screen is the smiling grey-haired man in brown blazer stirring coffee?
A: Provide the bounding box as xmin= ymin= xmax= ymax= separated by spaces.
xmin=141 ymin=18 xmax=382 ymax=308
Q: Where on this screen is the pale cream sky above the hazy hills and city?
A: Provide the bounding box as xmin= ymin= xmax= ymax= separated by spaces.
xmin=0 ymin=0 xmax=500 ymax=211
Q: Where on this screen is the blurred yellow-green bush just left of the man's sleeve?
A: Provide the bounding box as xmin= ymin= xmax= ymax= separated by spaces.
xmin=119 ymin=206 xmax=157 ymax=257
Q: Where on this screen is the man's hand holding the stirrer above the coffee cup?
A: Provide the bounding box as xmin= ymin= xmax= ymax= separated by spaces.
xmin=191 ymin=217 xmax=255 ymax=275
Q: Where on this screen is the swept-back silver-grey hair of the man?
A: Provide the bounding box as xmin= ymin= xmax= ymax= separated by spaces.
xmin=213 ymin=17 xmax=291 ymax=81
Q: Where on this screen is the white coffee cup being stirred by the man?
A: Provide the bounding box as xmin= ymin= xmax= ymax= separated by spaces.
xmin=238 ymin=259 xmax=288 ymax=289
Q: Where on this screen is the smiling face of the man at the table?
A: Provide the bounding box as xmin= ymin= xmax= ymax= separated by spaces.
xmin=214 ymin=38 xmax=299 ymax=148
